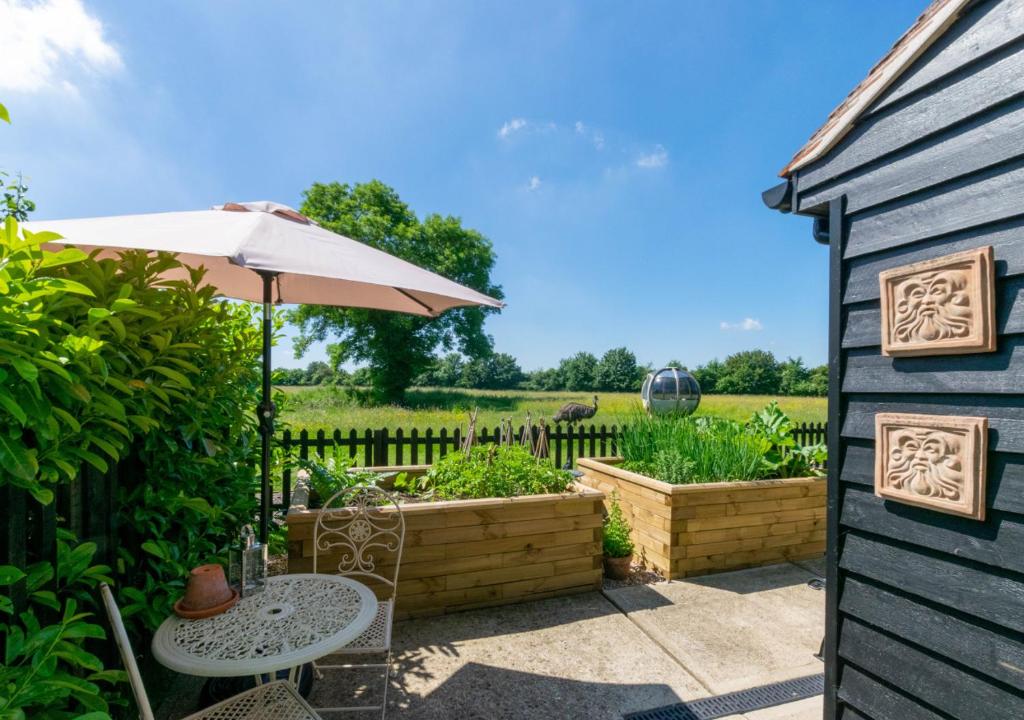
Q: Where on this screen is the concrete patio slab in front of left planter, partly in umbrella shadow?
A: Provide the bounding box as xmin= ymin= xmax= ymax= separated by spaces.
xmin=310 ymin=593 xmax=708 ymax=720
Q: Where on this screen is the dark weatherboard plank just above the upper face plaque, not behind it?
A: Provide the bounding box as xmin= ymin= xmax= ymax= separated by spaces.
xmin=845 ymin=157 xmax=1024 ymax=258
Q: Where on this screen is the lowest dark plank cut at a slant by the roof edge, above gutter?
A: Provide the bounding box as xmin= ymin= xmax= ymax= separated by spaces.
xmin=800 ymin=42 xmax=1024 ymax=192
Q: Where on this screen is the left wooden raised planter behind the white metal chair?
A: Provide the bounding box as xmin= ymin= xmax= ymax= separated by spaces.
xmin=287 ymin=465 xmax=604 ymax=618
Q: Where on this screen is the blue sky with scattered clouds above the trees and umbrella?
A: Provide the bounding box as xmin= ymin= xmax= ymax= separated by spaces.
xmin=0 ymin=0 xmax=926 ymax=370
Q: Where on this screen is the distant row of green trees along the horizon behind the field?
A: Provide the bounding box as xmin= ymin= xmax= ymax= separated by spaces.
xmin=274 ymin=347 xmax=828 ymax=395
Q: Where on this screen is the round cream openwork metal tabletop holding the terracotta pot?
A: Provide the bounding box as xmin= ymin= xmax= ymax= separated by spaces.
xmin=153 ymin=574 xmax=377 ymax=677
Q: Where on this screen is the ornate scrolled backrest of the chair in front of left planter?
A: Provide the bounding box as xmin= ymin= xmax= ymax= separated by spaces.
xmin=313 ymin=485 xmax=406 ymax=598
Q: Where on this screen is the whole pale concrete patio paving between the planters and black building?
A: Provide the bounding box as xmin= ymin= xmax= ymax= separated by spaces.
xmin=160 ymin=564 xmax=824 ymax=720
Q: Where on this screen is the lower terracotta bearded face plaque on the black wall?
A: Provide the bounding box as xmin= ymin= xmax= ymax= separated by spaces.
xmin=874 ymin=413 xmax=988 ymax=520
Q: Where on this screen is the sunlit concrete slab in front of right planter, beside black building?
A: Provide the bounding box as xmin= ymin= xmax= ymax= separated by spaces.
xmin=607 ymin=563 xmax=824 ymax=694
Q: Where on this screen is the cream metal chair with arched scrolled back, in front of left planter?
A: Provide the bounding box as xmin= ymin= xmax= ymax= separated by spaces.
xmin=313 ymin=485 xmax=406 ymax=718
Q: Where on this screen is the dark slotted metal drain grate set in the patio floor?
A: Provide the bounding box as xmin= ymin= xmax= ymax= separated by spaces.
xmin=624 ymin=675 xmax=824 ymax=720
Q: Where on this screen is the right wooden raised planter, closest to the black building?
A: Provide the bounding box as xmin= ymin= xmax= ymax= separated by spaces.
xmin=577 ymin=458 xmax=825 ymax=579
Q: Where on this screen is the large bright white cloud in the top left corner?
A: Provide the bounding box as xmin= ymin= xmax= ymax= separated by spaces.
xmin=0 ymin=0 xmax=123 ymax=94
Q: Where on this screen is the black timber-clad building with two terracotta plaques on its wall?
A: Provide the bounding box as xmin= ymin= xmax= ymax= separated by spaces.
xmin=764 ymin=0 xmax=1024 ymax=720
